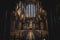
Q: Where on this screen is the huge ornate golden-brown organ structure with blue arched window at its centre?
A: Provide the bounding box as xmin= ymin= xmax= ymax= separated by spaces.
xmin=10 ymin=0 xmax=48 ymax=40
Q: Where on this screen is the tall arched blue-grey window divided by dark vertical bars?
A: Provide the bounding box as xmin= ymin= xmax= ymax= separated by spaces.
xmin=24 ymin=4 xmax=37 ymax=17
